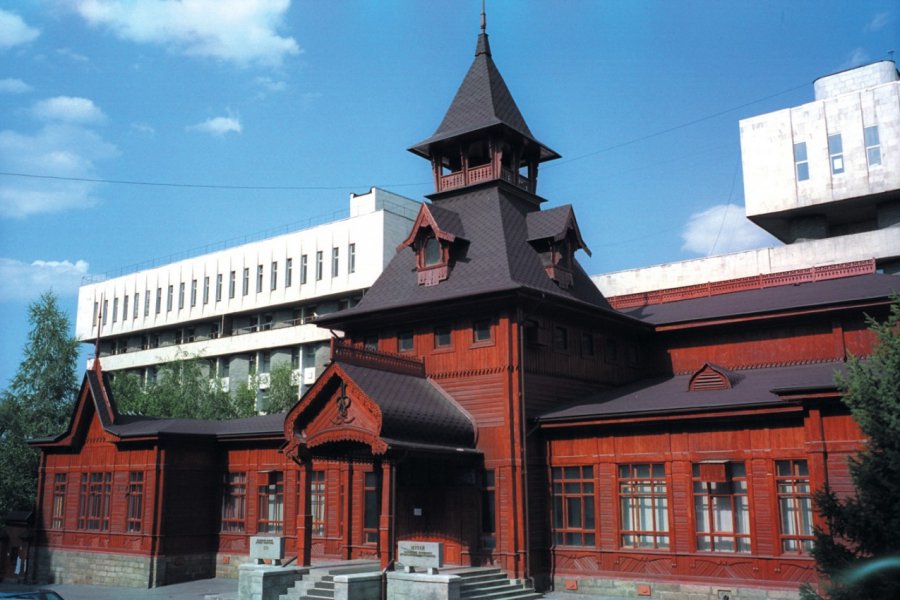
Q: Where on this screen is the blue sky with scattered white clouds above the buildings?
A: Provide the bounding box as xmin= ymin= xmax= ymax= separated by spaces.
xmin=0 ymin=0 xmax=900 ymax=387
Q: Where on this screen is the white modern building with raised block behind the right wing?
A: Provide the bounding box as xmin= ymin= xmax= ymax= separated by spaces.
xmin=593 ymin=61 xmax=900 ymax=297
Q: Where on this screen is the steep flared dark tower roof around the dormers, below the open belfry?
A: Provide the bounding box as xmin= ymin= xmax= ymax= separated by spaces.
xmin=319 ymin=182 xmax=618 ymax=326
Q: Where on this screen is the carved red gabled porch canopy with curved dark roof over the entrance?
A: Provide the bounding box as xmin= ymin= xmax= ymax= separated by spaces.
xmin=284 ymin=344 xmax=476 ymax=460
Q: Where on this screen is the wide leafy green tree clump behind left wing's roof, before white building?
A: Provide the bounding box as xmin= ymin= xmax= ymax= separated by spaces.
xmin=111 ymin=354 xmax=254 ymax=419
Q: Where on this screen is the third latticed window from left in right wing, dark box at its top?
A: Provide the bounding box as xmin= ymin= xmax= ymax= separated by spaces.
xmin=693 ymin=462 xmax=750 ymax=552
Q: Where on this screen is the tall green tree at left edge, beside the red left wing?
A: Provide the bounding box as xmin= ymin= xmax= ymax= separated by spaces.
xmin=0 ymin=292 xmax=78 ymax=514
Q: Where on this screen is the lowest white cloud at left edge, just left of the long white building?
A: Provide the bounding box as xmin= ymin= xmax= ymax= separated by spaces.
xmin=0 ymin=258 xmax=90 ymax=301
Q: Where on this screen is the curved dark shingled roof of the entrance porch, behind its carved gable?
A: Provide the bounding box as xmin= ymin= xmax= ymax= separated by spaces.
xmin=337 ymin=362 xmax=475 ymax=448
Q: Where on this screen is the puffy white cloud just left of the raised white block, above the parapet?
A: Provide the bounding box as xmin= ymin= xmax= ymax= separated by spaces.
xmin=681 ymin=204 xmax=779 ymax=256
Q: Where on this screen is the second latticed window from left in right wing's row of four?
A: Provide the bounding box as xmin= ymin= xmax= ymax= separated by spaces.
xmin=619 ymin=463 xmax=669 ymax=548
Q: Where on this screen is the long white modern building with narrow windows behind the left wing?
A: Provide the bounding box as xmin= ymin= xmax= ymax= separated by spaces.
xmin=75 ymin=188 xmax=419 ymax=398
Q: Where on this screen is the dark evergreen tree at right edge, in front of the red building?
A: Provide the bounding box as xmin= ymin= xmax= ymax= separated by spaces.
xmin=802 ymin=297 xmax=900 ymax=600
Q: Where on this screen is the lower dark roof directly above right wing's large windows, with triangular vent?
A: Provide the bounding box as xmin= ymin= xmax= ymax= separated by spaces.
xmin=539 ymin=362 xmax=844 ymax=423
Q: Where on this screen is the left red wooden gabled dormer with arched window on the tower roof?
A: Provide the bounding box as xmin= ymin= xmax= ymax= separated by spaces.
xmin=397 ymin=204 xmax=463 ymax=286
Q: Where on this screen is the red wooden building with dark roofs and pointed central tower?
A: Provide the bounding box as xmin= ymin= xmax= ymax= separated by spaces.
xmin=28 ymin=21 xmax=900 ymax=593
